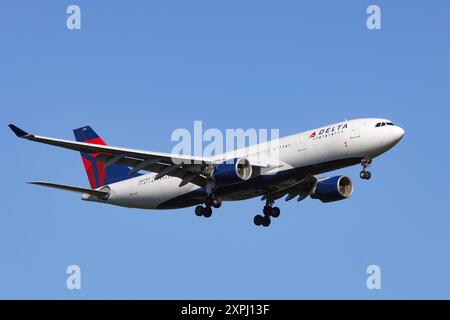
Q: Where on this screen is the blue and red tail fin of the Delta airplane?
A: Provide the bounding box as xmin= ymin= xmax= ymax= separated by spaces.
xmin=73 ymin=126 xmax=139 ymax=189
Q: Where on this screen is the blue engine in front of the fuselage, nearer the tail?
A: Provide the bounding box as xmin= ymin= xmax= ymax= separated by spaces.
xmin=213 ymin=158 xmax=252 ymax=184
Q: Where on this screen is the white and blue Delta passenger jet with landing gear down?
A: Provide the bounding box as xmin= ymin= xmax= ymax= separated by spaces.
xmin=9 ymin=118 xmax=404 ymax=227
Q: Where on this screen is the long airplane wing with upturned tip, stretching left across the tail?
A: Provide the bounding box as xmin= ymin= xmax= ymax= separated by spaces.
xmin=9 ymin=124 xmax=214 ymax=186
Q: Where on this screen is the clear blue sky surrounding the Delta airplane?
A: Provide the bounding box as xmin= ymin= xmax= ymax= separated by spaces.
xmin=0 ymin=0 xmax=450 ymax=299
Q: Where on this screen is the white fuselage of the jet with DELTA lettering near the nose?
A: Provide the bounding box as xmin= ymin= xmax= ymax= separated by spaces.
xmin=83 ymin=118 xmax=404 ymax=209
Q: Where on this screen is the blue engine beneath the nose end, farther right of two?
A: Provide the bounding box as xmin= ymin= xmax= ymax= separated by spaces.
xmin=311 ymin=176 xmax=353 ymax=202
